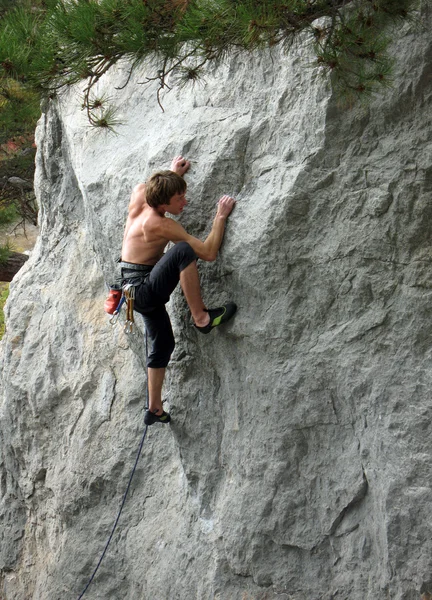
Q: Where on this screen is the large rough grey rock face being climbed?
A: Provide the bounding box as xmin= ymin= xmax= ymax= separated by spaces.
xmin=0 ymin=2 xmax=432 ymax=600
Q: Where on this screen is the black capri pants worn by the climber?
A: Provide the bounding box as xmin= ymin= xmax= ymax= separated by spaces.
xmin=128 ymin=242 xmax=197 ymax=369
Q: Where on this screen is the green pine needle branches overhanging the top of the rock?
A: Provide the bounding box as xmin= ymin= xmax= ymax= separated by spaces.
xmin=0 ymin=0 xmax=415 ymax=126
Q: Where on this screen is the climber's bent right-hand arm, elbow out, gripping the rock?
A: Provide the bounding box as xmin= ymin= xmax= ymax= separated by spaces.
xmin=158 ymin=196 xmax=235 ymax=262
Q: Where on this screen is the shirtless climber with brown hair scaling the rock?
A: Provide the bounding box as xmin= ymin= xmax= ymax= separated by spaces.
xmin=121 ymin=156 xmax=237 ymax=425
